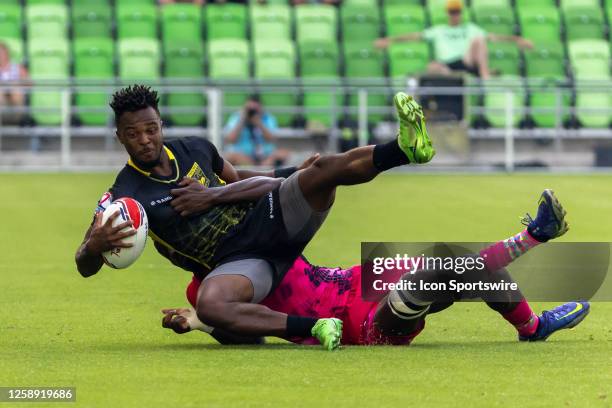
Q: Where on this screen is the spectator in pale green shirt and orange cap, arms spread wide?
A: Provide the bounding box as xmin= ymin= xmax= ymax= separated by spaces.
xmin=374 ymin=0 xmax=533 ymax=79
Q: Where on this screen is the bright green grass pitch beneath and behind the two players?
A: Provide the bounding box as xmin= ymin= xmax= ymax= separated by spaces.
xmin=0 ymin=174 xmax=612 ymax=408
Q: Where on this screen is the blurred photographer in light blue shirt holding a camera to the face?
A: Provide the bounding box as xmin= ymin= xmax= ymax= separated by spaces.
xmin=225 ymin=95 xmax=289 ymax=166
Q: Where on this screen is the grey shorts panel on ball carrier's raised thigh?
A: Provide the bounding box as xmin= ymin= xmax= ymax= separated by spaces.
xmin=278 ymin=172 xmax=329 ymax=241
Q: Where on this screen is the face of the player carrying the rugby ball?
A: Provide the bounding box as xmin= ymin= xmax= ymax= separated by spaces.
xmin=117 ymin=108 xmax=163 ymax=168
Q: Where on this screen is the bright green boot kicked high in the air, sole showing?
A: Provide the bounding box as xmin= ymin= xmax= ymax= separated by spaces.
xmin=393 ymin=92 xmax=436 ymax=164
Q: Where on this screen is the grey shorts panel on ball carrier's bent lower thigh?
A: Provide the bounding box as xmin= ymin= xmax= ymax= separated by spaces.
xmin=204 ymin=258 xmax=274 ymax=303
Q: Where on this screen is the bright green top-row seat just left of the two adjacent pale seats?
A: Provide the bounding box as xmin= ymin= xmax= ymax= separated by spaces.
xmin=204 ymin=3 xmax=247 ymax=41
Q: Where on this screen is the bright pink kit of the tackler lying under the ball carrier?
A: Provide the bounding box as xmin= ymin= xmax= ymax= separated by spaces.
xmin=187 ymin=257 xmax=425 ymax=345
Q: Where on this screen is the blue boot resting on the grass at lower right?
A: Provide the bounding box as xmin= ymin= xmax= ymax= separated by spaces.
xmin=519 ymin=302 xmax=591 ymax=341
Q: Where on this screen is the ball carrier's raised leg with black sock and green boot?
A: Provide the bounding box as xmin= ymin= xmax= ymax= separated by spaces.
xmin=298 ymin=92 xmax=435 ymax=211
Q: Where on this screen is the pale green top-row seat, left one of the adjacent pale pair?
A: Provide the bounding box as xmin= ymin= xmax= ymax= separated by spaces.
xmin=250 ymin=4 xmax=291 ymax=41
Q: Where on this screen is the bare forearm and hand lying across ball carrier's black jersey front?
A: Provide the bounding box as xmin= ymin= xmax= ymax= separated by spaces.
xmin=170 ymin=177 xmax=282 ymax=216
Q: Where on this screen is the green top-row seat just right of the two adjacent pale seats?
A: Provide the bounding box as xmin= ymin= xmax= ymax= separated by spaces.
xmin=340 ymin=5 xmax=380 ymax=47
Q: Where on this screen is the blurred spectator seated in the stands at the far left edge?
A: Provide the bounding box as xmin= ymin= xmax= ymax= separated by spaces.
xmin=0 ymin=43 xmax=28 ymax=124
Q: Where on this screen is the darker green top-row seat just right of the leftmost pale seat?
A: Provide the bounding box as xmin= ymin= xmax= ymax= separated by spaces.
xmin=72 ymin=3 xmax=112 ymax=38
